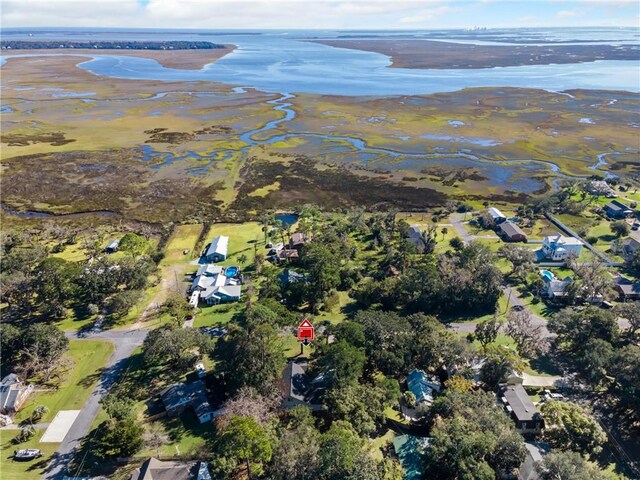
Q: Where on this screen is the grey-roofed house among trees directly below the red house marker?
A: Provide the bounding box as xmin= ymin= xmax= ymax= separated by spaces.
xmin=282 ymin=360 xmax=329 ymax=411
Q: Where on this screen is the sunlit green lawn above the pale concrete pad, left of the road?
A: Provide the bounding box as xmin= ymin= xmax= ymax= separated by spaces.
xmin=16 ymin=340 xmax=113 ymax=424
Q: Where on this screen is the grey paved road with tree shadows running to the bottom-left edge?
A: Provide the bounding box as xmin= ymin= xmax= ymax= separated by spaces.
xmin=43 ymin=329 xmax=148 ymax=480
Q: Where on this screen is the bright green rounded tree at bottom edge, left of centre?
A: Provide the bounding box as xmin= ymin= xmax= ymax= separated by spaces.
xmin=216 ymin=416 xmax=273 ymax=479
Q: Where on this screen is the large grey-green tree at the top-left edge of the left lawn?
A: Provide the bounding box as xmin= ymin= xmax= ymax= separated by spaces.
xmin=18 ymin=323 xmax=69 ymax=382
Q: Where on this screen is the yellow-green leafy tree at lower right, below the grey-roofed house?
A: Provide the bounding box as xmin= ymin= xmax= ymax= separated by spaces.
xmin=540 ymin=400 xmax=607 ymax=455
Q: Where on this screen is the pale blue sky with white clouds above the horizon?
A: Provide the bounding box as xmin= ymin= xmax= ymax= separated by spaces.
xmin=0 ymin=0 xmax=640 ymax=30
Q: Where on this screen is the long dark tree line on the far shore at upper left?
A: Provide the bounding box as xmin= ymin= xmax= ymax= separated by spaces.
xmin=0 ymin=40 xmax=225 ymax=50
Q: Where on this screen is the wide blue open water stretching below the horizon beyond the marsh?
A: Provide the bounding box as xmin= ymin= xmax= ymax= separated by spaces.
xmin=3 ymin=29 xmax=640 ymax=96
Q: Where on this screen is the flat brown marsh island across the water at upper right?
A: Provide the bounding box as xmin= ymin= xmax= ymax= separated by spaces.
xmin=310 ymin=38 xmax=640 ymax=70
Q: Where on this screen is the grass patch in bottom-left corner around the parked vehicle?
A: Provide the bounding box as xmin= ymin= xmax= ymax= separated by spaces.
xmin=0 ymin=429 xmax=59 ymax=480
